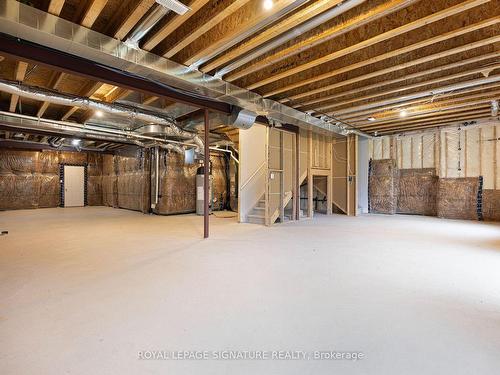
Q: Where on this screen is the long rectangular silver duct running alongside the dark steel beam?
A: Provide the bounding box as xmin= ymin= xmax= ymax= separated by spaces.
xmin=0 ymin=0 xmax=369 ymax=137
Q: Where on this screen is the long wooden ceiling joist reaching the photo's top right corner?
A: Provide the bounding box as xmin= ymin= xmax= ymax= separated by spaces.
xmin=247 ymin=0 xmax=490 ymax=90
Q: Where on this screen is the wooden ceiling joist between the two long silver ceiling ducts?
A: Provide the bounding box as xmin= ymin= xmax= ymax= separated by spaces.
xmin=202 ymin=0 xmax=341 ymax=72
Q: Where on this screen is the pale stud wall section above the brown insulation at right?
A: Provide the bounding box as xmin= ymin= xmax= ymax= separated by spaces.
xmin=369 ymin=121 xmax=500 ymax=189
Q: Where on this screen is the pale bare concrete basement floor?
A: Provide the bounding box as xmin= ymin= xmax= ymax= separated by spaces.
xmin=0 ymin=207 xmax=500 ymax=375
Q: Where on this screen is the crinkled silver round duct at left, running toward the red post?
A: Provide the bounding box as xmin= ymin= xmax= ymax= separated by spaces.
xmin=0 ymin=80 xmax=204 ymax=152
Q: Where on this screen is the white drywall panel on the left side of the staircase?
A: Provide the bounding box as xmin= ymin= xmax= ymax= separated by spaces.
xmin=238 ymin=124 xmax=267 ymax=222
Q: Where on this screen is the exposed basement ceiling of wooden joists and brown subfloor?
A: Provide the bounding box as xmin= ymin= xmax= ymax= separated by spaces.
xmin=0 ymin=0 xmax=500 ymax=134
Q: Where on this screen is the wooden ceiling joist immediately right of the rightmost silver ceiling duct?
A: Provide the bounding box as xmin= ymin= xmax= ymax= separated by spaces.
xmin=224 ymin=0 xmax=419 ymax=82
